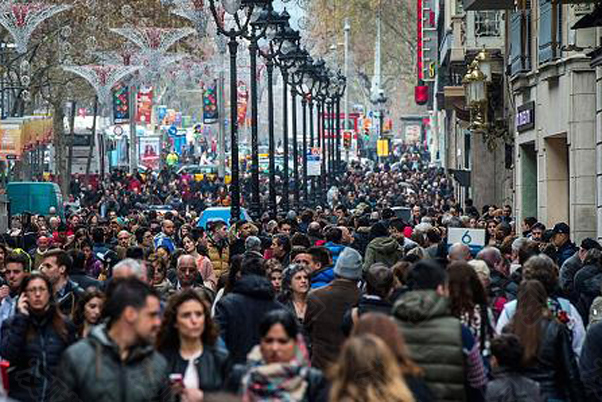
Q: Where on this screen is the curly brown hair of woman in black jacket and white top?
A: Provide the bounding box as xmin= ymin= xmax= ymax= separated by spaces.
xmin=157 ymin=289 xmax=218 ymax=352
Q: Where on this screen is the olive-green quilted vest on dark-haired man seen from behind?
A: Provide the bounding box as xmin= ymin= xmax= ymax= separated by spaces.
xmin=393 ymin=290 xmax=466 ymax=402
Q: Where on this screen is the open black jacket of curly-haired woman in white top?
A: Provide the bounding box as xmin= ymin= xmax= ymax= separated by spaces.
xmin=162 ymin=345 xmax=229 ymax=393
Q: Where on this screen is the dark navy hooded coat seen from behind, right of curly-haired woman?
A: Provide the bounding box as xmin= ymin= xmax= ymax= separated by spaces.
xmin=215 ymin=275 xmax=284 ymax=364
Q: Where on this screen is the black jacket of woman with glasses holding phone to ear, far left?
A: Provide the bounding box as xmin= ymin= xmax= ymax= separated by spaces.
xmin=0 ymin=312 xmax=76 ymax=402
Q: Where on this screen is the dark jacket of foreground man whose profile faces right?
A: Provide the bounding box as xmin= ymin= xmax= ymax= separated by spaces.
xmin=53 ymin=325 xmax=173 ymax=402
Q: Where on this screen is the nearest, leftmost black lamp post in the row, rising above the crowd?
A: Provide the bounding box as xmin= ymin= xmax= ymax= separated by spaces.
xmin=209 ymin=0 xmax=263 ymax=224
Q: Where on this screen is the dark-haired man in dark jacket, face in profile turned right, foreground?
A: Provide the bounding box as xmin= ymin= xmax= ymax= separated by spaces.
xmin=53 ymin=278 xmax=172 ymax=402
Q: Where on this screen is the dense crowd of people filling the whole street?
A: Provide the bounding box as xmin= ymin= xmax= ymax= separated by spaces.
xmin=0 ymin=148 xmax=602 ymax=402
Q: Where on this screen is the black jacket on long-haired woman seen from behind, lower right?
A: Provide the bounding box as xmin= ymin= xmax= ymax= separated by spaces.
xmin=524 ymin=319 xmax=585 ymax=402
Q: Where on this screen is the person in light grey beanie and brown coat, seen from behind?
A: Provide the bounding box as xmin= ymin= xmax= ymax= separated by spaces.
xmin=304 ymin=247 xmax=362 ymax=369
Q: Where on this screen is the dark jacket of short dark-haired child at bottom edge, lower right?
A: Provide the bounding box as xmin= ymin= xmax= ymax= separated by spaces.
xmin=485 ymin=369 xmax=544 ymax=402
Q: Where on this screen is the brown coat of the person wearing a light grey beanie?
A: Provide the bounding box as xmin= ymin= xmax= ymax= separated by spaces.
xmin=304 ymin=279 xmax=360 ymax=369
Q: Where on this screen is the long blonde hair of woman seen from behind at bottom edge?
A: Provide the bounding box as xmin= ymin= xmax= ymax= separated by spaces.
xmin=330 ymin=334 xmax=414 ymax=402
